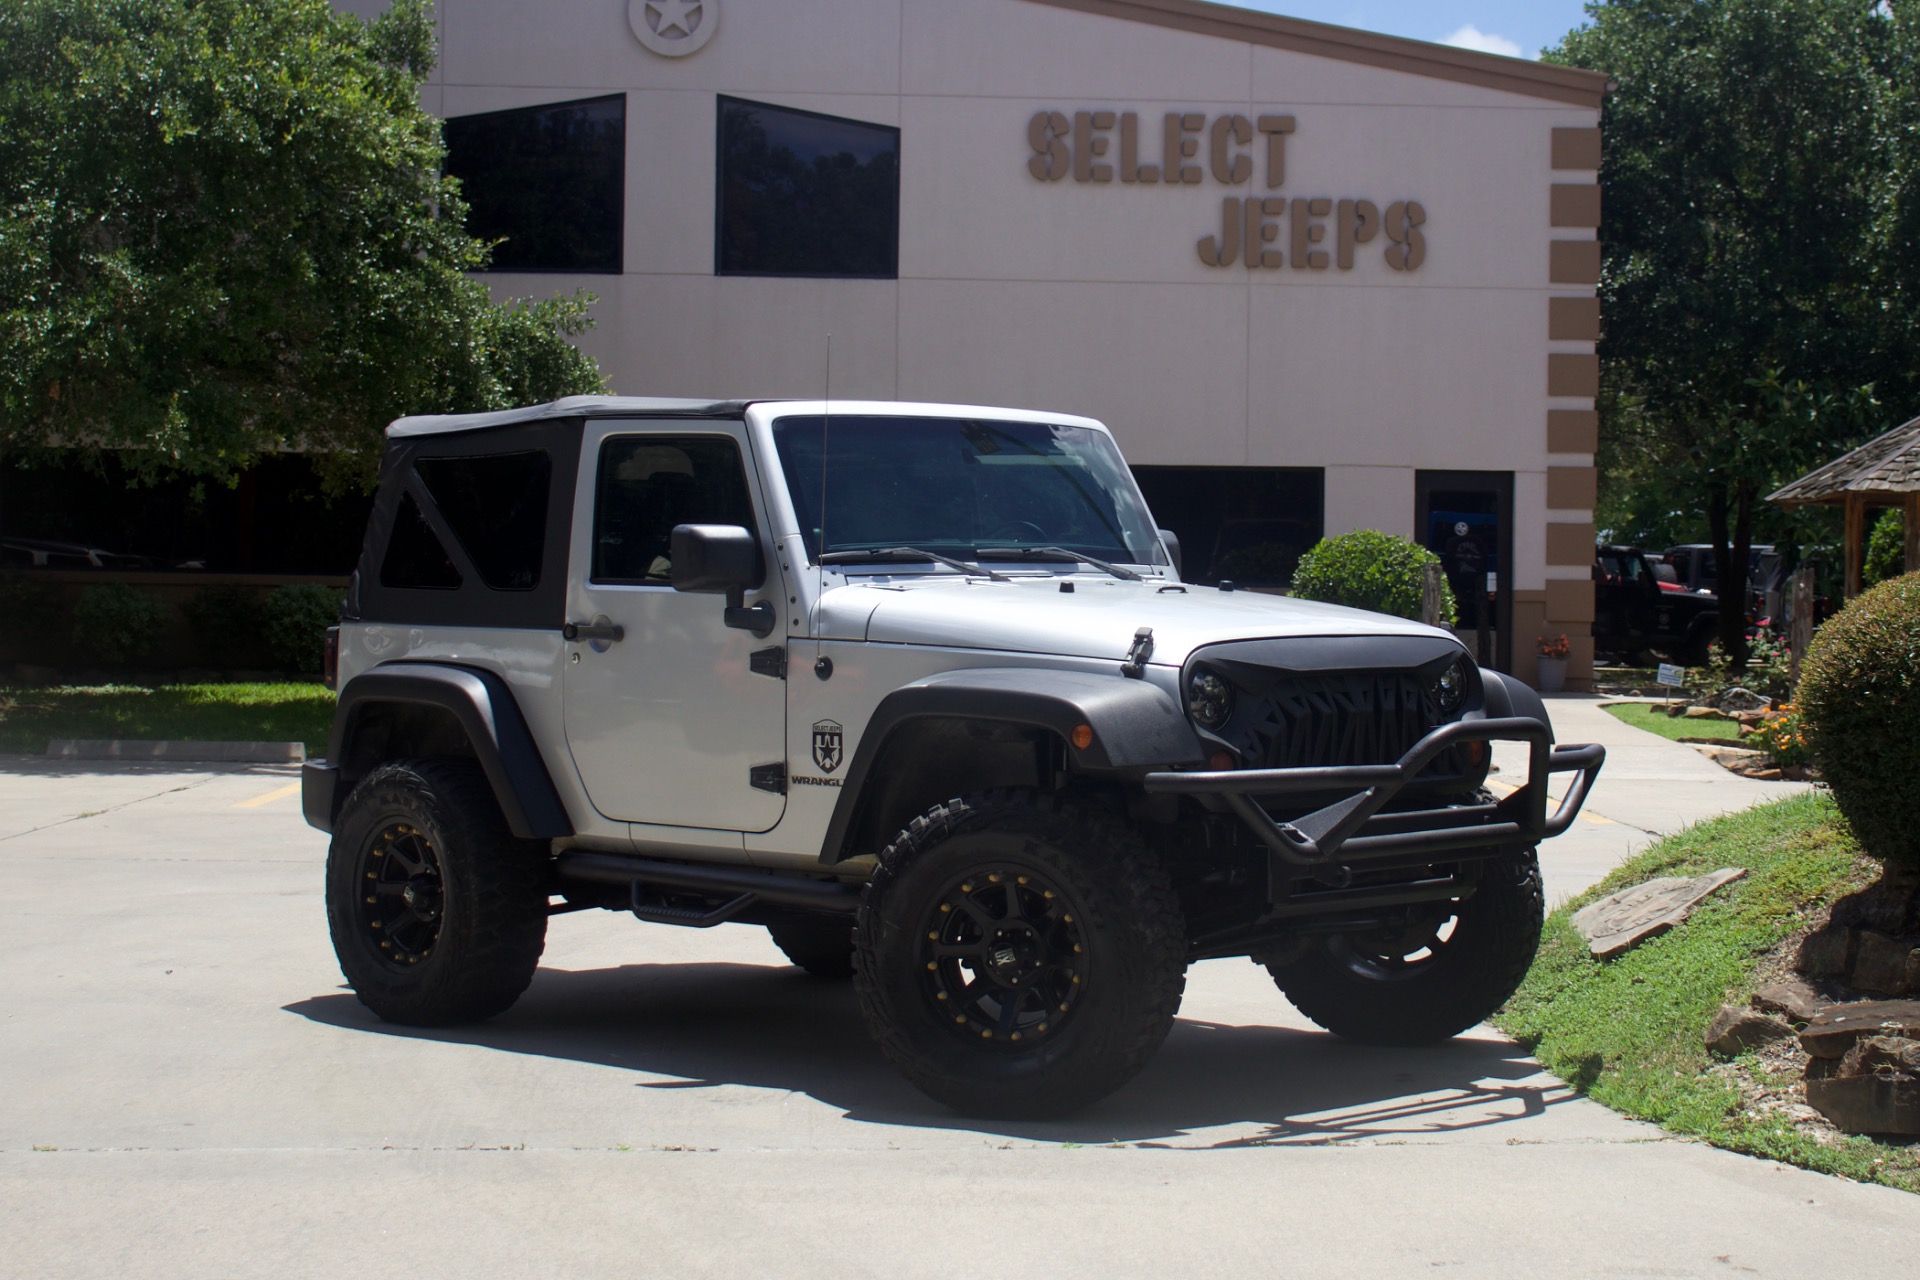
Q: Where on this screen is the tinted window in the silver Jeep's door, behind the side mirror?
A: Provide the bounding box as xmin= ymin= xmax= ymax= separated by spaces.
xmin=593 ymin=436 xmax=755 ymax=585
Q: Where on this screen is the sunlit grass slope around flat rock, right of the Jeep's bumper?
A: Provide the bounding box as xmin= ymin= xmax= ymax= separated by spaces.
xmin=1494 ymin=794 xmax=1920 ymax=1192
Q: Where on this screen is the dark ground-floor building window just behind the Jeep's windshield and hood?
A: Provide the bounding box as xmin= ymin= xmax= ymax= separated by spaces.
xmin=1133 ymin=466 xmax=1327 ymax=587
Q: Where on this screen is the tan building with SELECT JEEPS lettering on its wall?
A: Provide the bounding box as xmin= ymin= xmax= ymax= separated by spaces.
xmin=348 ymin=0 xmax=1605 ymax=681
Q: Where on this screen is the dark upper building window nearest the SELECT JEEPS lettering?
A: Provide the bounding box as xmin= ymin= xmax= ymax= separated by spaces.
xmin=714 ymin=98 xmax=900 ymax=280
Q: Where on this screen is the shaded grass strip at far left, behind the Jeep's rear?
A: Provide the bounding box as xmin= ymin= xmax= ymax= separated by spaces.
xmin=0 ymin=683 xmax=334 ymax=754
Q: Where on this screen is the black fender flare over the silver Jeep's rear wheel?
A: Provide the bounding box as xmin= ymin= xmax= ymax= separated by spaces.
xmin=326 ymin=662 xmax=574 ymax=841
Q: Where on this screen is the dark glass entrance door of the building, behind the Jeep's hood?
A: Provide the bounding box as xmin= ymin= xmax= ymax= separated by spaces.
xmin=1413 ymin=470 xmax=1513 ymax=672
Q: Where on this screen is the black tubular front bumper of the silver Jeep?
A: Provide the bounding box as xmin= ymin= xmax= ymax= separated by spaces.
xmin=1144 ymin=716 xmax=1607 ymax=883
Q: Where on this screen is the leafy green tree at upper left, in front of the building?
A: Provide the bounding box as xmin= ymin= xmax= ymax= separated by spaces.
xmin=0 ymin=0 xmax=603 ymax=484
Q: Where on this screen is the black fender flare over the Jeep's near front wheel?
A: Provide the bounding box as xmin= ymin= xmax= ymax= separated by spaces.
xmin=820 ymin=668 xmax=1206 ymax=865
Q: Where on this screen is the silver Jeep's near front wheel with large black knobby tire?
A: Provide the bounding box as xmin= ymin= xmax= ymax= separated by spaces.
xmin=854 ymin=793 xmax=1187 ymax=1117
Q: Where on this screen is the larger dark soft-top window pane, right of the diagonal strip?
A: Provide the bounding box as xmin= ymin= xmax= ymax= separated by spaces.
xmin=413 ymin=449 xmax=553 ymax=591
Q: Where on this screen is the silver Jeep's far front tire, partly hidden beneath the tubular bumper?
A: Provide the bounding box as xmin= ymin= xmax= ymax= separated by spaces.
xmin=1254 ymin=850 xmax=1544 ymax=1046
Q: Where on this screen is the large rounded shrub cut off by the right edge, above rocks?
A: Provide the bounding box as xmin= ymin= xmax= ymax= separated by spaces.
xmin=1797 ymin=574 xmax=1920 ymax=867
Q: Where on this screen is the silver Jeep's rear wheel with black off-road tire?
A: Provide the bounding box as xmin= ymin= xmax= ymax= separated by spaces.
xmin=326 ymin=760 xmax=547 ymax=1027
